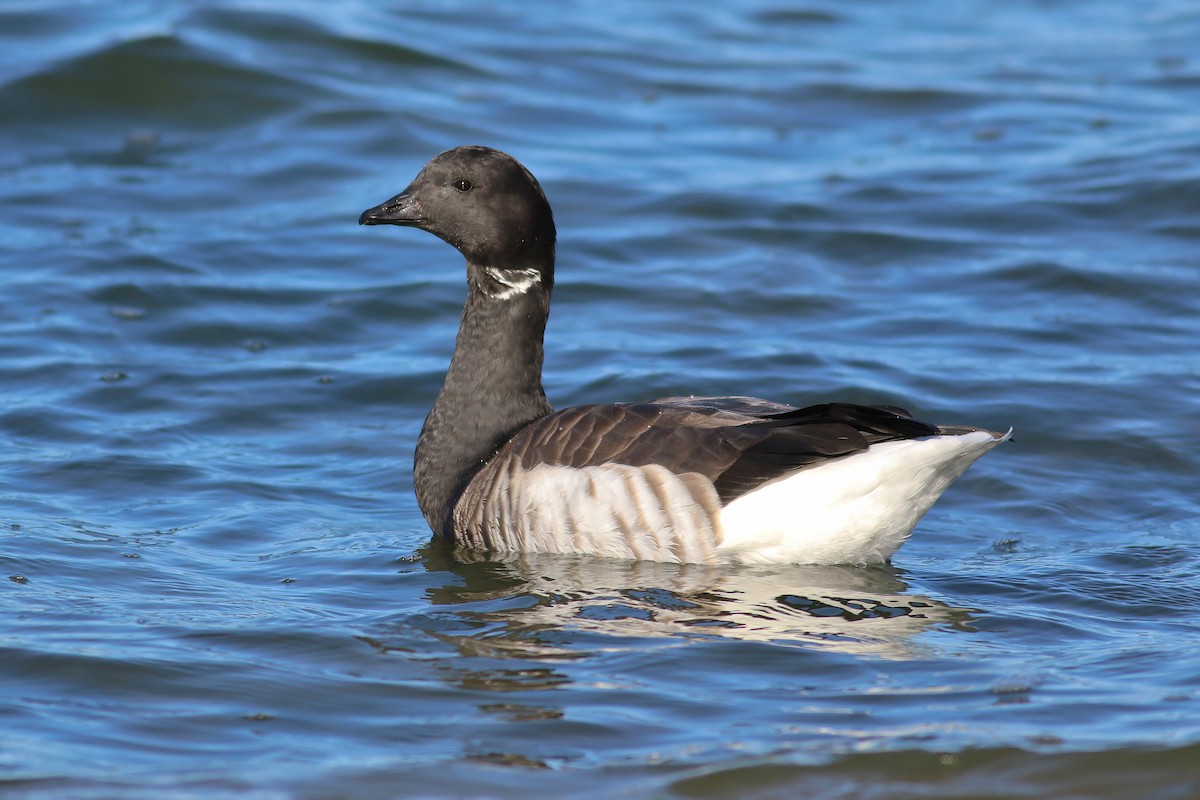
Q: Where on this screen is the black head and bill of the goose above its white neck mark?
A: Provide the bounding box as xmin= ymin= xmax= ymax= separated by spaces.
xmin=359 ymin=145 xmax=554 ymax=289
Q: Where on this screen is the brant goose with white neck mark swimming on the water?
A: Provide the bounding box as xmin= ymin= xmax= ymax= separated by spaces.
xmin=359 ymin=146 xmax=1009 ymax=564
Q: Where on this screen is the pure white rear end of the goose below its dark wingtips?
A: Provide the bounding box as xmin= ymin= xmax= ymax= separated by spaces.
xmin=719 ymin=431 xmax=1012 ymax=564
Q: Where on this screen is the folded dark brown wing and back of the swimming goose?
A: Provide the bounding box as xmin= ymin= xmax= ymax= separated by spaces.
xmin=499 ymin=398 xmax=938 ymax=503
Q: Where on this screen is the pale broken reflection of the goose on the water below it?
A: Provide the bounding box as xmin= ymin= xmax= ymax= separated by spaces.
xmin=422 ymin=545 xmax=973 ymax=660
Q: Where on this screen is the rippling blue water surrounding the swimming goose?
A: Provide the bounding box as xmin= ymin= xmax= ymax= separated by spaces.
xmin=0 ymin=0 xmax=1200 ymax=800
